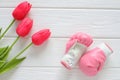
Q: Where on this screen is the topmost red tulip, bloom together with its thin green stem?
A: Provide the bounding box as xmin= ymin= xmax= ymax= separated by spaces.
xmin=0 ymin=1 xmax=31 ymax=39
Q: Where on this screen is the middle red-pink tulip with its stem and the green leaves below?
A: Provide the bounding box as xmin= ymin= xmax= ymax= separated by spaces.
xmin=0 ymin=18 xmax=33 ymax=73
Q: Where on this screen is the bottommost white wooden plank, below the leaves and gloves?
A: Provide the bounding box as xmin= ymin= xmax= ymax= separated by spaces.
xmin=0 ymin=67 xmax=120 ymax=80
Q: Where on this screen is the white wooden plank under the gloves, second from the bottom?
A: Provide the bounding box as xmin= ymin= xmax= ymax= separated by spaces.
xmin=0 ymin=38 xmax=120 ymax=68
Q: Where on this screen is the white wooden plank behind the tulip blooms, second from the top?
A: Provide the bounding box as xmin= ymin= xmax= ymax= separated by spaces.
xmin=0 ymin=8 xmax=120 ymax=38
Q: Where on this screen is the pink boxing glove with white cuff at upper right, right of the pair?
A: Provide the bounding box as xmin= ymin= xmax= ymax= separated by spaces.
xmin=79 ymin=43 xmax=113 ymax=76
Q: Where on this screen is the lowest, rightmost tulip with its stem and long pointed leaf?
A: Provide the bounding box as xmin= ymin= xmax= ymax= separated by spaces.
xmin=0 ymin=27 xmax=51 ymax=74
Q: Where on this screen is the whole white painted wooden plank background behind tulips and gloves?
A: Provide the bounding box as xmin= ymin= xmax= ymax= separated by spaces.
xmin=0 ymin=0 xmax=120 ymax=80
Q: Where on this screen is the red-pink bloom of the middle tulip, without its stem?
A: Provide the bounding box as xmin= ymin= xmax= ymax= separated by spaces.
xmin=16 ymin=18 xmax=33 ymax=37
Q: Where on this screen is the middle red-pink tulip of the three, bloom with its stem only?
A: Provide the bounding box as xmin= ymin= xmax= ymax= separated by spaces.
xmin=0 ymin=18 xmax=33 ymax=56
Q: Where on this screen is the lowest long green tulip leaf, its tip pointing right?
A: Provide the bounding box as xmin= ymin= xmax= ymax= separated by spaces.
xmin=0 ymin=57 xmax=26 ymax=74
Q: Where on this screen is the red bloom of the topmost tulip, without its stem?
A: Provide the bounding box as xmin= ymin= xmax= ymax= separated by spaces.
xmin=12 ymin=1 xmax=32 ymax=20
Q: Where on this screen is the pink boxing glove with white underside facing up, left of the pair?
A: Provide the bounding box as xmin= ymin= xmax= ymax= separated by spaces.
xmin=61 ymin=32 xmax=93 ymax=69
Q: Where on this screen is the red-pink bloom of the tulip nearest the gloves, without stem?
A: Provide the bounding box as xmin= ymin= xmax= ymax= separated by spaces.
xmin=32 ymin=29 xmax=51 ymax=45
